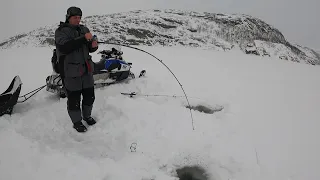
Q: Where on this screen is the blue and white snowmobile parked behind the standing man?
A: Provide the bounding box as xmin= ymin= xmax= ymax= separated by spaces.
xmin=46 ymin=47 xmax=146 ymax=98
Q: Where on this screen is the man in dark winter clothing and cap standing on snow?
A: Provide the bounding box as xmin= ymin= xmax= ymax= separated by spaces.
xmin=55 ymin=7 xmax=98 ymax=132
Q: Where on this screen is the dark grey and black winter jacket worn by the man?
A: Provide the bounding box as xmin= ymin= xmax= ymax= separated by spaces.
xmin=55 ymin=22 xmax=98 ymax=91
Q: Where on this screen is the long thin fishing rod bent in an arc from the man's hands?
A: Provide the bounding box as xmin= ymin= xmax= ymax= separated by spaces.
xmin=97 ymin=41 xmax=194 ymax=130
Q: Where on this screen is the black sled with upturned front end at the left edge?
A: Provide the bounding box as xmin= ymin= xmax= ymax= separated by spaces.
xmin=0 ymin=76 xmax=22 ymax=116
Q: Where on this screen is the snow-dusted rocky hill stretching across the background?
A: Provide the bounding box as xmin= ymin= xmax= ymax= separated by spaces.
xmin=0 ymin=10 xmax=320 ymax=65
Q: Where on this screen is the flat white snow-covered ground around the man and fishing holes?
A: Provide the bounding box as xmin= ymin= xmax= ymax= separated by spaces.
xmin=0 ymin=44 xmax=320 ymax=180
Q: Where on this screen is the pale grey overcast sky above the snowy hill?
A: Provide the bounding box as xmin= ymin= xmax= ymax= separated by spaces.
xmin=0 ymin=0 xmax=320 ymax=50
